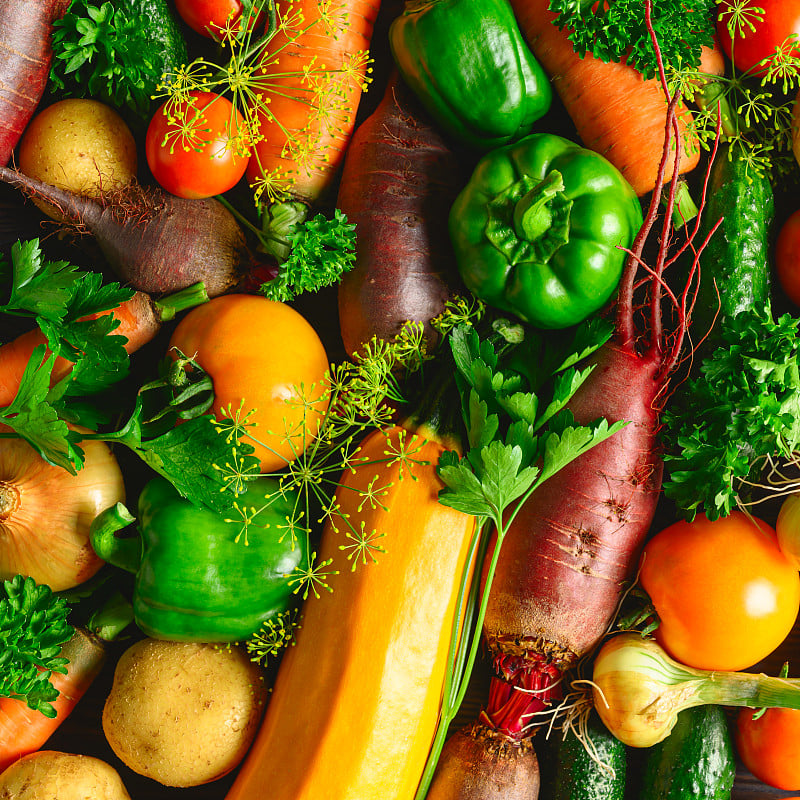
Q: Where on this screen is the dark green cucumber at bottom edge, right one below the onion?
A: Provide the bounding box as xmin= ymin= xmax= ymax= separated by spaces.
xmin=639 ymin=706 xmax=736 ymax=800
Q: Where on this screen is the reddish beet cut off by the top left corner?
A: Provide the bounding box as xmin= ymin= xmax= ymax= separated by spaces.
xmin=0 ymin=0 xmax=69 ymax=165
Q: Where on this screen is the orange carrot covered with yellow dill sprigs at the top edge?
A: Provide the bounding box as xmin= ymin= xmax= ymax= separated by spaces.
xmin=247 ymin=0 xmax=380 ymax=203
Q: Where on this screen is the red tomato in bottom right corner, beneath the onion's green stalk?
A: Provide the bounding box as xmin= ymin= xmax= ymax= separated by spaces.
xmin=735 ymin=708 xmax=800 ymax=791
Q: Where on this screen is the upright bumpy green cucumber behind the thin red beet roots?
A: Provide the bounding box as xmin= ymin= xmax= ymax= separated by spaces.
xmin=692 ymin=148 xmax=775 ymax=352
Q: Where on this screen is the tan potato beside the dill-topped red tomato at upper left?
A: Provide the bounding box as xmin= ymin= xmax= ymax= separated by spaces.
xmin=19 ymin=100 xmax=137 ymax=219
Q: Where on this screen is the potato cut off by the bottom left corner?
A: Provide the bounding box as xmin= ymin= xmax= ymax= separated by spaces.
xmin=0 ymin=750 xmax=131 ymax=800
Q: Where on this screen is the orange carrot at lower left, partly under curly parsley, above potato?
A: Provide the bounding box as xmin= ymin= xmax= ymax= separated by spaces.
xmin=0 ymin=629 xmax=105 ymax=772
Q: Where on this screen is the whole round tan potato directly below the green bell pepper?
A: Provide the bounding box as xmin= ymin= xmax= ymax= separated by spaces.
xmin=103 ymin=639 xmax=267 ymax=786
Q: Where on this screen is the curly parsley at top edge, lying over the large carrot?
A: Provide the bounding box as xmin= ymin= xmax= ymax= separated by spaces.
xmin=550 ymin=0 xmax=717 ymax=78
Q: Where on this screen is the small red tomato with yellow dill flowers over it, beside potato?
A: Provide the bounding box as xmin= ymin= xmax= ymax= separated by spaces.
xmin=145 ymin=91 xmax=249 ymax=200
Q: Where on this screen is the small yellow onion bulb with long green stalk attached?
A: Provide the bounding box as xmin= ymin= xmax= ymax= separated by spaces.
xmin=592 ymin=633 xmax=800 ymax=747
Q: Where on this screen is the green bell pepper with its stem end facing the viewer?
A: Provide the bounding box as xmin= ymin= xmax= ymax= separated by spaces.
xmin=450 ymin=133 xmax=642 ymax=328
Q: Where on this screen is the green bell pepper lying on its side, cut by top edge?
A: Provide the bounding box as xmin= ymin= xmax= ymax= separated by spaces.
xmin=389 ymin=0 xmax=553 ymax=149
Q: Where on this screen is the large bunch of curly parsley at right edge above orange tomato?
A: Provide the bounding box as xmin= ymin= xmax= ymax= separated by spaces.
xmin=663 ymin=308 xmax=800 ymax=519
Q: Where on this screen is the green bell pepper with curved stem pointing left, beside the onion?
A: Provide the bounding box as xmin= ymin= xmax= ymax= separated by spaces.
xmin=91 ymin=477 xmax=306 ymax=642
